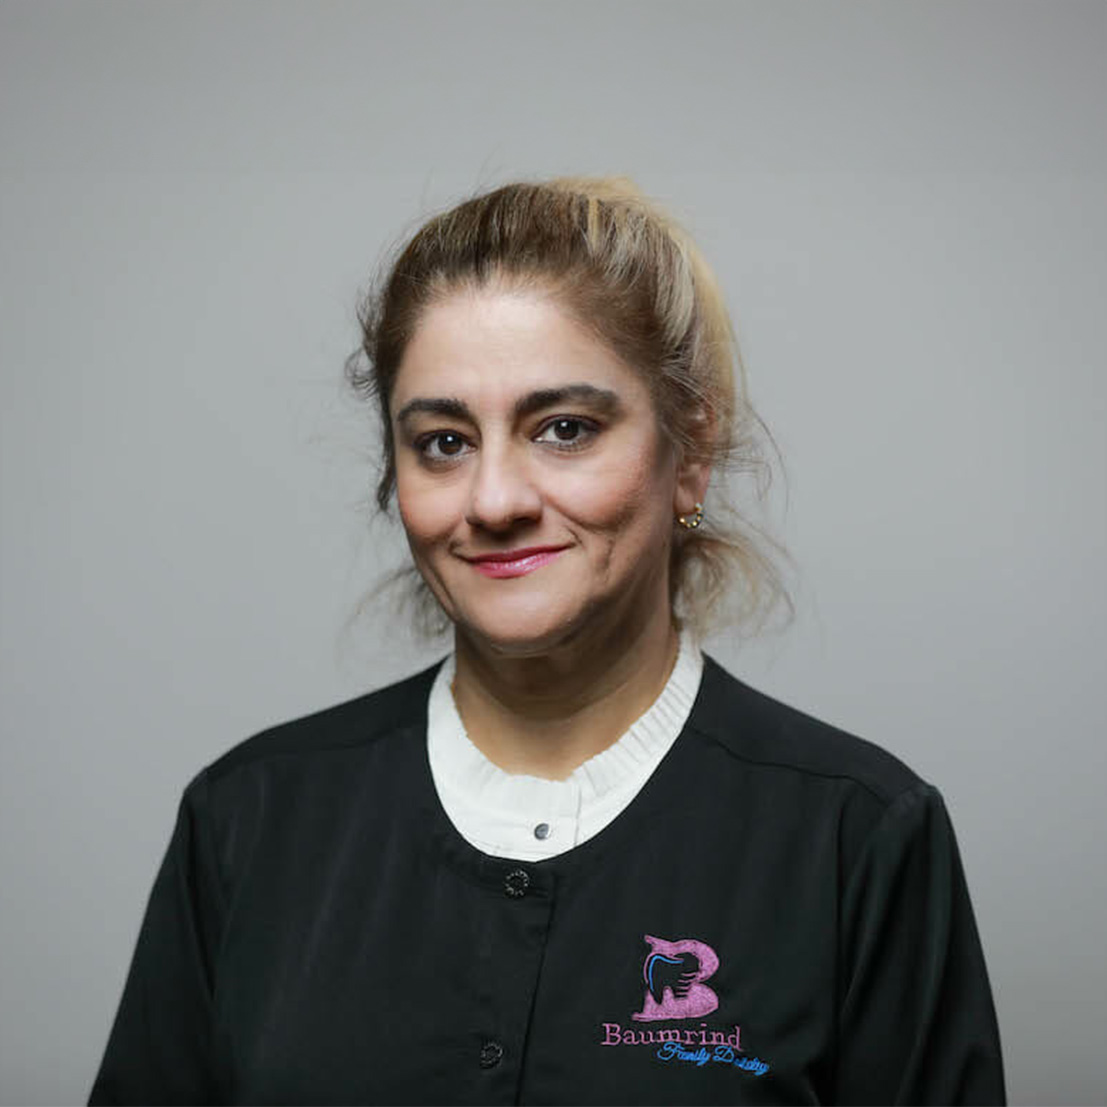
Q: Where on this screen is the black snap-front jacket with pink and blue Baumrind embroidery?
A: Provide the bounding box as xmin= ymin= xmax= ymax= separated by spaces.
xmin=90 ymin=659 xmax=1004 ymax=1104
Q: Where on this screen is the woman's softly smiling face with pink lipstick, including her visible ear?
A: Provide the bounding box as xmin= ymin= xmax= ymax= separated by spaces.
xmin=390 ymin=281 xmax=706 ymax=655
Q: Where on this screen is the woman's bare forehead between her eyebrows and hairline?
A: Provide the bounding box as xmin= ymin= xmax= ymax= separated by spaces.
xmin=391 ymin=289 xmax=649 ymax=411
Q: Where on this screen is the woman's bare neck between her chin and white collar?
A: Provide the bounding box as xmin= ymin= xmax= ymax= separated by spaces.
xmin=453 ymin=608 xmax=679 ymax=780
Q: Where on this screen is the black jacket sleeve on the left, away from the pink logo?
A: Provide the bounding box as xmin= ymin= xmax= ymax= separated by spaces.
xmin=89 ymin=774 xmax=224 ymax=1104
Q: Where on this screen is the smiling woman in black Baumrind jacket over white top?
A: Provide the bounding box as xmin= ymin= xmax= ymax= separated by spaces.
xmin=92 ymin=179 xmax=1004 ymax=1104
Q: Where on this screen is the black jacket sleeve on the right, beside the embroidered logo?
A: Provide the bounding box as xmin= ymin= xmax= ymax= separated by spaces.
xmin=835 ymin=785 xmax=1005 ymax=1104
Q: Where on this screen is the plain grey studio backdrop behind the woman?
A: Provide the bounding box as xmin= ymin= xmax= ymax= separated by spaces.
xmin=0 ymin=0 xmax=1107 ymax=1104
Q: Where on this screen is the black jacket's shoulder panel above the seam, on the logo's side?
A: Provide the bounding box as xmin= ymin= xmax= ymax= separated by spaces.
xmin=689 ymin=656 xmax=932 ymax=807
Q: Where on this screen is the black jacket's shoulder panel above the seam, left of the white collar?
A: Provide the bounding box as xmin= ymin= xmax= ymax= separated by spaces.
xmin=200 ymin=661 xmax=442 ymax=783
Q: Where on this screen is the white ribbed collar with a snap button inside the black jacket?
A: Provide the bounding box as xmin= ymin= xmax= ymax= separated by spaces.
xmin=426 ymin=630 xmax=703 ymax=861
